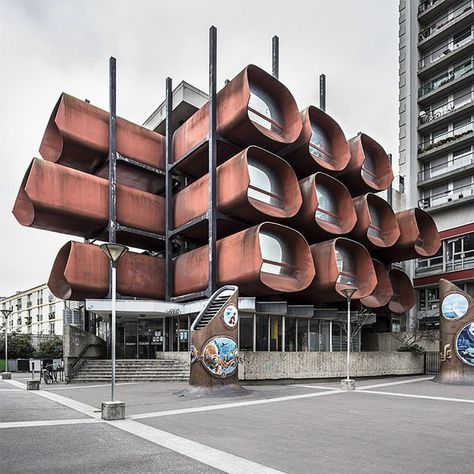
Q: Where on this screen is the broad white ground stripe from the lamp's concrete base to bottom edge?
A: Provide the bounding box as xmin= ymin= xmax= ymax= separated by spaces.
xmin=111 ymin=420 xmax=282 ymax=474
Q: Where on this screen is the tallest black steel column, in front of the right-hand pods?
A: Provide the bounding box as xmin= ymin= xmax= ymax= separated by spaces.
xmin=207 ymin=26 xmax=217 ymax=296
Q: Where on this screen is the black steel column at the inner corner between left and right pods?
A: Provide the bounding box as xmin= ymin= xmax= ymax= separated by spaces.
xmin=165 ymin=77 xmax=174 ymax=301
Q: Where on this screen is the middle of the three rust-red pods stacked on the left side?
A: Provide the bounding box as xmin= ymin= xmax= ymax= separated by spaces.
xmin=13 ymin=158 xmax=165 ymax=250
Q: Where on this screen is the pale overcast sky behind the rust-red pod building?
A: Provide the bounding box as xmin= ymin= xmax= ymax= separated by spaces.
xmin=0 ymin=0 xmax=398 ymax=296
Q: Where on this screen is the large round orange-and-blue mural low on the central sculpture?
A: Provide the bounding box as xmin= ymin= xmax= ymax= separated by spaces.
xmin=202 ymin=336 xmax=239 ymax=378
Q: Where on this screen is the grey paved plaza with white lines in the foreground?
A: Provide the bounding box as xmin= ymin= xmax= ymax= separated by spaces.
xmin=0 ymin=374 xmax=474 ymax=474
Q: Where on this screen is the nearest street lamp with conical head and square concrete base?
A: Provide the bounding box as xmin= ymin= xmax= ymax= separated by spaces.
xmin=100 ymin=242 xmax=128 ymax=420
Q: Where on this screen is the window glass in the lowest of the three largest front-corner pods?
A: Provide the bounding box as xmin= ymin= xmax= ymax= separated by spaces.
xmin=259 ymin=232 xmax=296 ymax=276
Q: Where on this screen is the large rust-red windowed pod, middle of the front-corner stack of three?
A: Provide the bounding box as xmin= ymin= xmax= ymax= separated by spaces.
xmin=173 ymin=146 xmax=302 ymax=240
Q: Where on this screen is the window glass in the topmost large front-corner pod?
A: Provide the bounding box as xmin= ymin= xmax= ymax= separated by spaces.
xmin=247 ymin=82 xmax=284 ymax=133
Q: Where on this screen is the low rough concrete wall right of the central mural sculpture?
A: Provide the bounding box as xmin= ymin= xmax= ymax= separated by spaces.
xmin=239 ymin=352 xmax=424 ymax=380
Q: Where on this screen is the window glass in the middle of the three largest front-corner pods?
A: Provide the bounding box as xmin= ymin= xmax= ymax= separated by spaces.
xmin=247 ymin=160 xmax=283 ymax=208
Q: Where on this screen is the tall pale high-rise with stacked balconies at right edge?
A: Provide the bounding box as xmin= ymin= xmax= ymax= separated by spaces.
xmin=399 ymin=0 xmax=474 ymax=328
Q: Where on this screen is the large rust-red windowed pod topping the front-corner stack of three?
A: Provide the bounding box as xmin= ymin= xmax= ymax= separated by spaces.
xmin=173 ymin=65 xmax=302 ymax=177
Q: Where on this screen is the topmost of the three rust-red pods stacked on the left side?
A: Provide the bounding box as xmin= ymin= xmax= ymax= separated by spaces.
xmin=40 ymin=93 xmax=165 ymax=192
